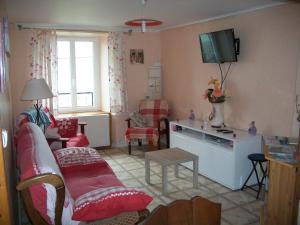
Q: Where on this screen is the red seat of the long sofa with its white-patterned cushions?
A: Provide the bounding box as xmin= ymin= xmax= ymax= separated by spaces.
xmin=55 ymin=148 xmax=152 ymax=221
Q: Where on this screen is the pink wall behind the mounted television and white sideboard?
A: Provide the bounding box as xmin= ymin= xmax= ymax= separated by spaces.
xmin=161 ymin=4 xmax=300 ymax=136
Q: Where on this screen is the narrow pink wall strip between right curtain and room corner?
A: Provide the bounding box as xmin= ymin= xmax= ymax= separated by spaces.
xmin=112 ymin=32 xmax=160 ymax=145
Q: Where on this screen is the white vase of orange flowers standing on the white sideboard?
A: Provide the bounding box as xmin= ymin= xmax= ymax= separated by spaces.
xmin=204 ymin=78 xmax=226 ymax=127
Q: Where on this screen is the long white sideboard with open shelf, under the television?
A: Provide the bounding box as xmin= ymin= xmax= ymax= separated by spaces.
xmin=170 ymin=120 xmax=262 ymax=190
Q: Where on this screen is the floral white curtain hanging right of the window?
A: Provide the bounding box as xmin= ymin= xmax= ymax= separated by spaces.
xmin=108 ymin=32 xmax=127 ymax=113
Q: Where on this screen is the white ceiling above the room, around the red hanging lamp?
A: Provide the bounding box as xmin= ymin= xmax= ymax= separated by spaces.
xmin=5 ymin=0 xmax=282 ymax=31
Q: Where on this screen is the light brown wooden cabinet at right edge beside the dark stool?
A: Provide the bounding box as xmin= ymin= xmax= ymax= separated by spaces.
xmin=263 ymin=148 xmax=300 ymax=225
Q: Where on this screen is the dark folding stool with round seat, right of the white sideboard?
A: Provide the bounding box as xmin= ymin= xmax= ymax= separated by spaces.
xmin=241 ymin=153 xmax=267 ymax=199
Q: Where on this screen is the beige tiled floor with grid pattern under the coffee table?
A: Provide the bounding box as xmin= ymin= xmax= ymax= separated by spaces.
xmin=22 ymin=147 xmax=263 ymax=225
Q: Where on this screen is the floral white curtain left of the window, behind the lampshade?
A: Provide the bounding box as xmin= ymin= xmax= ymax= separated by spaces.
xmin=29 ymin=30 xmax=58 ymax=115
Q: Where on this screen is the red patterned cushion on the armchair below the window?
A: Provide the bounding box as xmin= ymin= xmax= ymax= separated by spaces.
xmin=56 ymin=118 xmax=78 ymax=138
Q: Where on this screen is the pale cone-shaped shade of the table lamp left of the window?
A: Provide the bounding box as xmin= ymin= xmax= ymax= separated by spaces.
xmin=21 ymin=79 xmax=54 ymax=101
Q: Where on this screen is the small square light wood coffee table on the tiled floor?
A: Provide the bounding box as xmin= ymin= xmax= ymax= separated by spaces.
xmin=145 ymin=148 xmax=198 ymax=194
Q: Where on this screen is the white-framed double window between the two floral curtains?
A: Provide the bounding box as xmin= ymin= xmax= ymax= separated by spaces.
xmin=57 ymin=36 xmax=106 ymax=113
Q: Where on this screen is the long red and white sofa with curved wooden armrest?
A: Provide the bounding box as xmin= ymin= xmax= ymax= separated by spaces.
xmin=17 ymin=123 xmax=152 ymax=225
